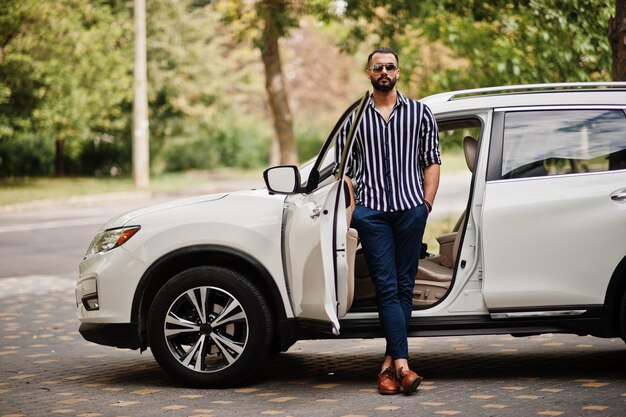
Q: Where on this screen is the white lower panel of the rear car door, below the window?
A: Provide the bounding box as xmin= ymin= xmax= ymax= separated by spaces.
xmin=483 ymin=172 xmax=626 ymax=308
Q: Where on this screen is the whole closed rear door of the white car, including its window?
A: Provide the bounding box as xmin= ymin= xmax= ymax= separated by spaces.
xmin=483 ymin=108 xmax=626 ymax=309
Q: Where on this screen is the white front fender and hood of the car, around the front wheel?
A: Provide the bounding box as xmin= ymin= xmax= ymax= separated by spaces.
xmin=79 ymin=190 xmax=292 ymax=323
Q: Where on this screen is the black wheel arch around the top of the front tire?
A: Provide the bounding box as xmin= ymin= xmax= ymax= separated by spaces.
xmin=131 ymin=245 xmax=286 ymax=349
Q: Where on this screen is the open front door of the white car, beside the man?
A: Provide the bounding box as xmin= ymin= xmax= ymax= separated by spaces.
xmin=268 ymin=93 xmax=369 ymax=334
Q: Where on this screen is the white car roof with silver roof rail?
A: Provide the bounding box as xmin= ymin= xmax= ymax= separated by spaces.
xmin=420 ymin=82 xmax=626 ymax=114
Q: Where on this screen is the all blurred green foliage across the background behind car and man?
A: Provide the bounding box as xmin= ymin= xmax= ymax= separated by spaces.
xmin=0 ymin=0 xmax=615 ymax=176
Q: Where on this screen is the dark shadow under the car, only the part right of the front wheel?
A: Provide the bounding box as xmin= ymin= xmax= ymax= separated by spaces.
xmin=255 ymin=345 xmax=626 ymax=383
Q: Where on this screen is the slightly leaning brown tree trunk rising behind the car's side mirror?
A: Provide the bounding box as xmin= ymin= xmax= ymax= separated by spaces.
xmin=261 ymin=0 xmax=298 ymax=164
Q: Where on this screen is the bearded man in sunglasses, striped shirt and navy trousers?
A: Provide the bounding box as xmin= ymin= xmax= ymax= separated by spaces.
xmin=336 ymin=48 xmax=441 ymax=395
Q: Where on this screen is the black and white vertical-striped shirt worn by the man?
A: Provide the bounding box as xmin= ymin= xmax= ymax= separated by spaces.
xmin=335 ymin=92 xmax=441 ymax=211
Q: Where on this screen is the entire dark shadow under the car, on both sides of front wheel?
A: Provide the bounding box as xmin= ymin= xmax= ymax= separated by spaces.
xmin=70 ymin=342 xmax=626 ymax=388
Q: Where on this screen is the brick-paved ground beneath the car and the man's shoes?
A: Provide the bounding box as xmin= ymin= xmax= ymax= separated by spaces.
xmin=0 ymin=276 xmax=626 ymax=417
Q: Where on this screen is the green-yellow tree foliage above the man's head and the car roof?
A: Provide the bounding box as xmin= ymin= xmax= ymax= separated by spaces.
xmin=336 ymin=0 xmax=608 ymax=97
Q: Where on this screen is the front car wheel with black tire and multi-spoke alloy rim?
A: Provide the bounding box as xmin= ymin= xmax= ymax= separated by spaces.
xmin=148 ymin=266 xmax=273 ymax=388
